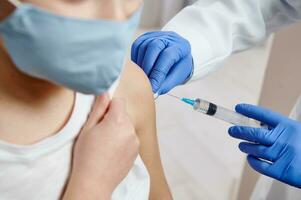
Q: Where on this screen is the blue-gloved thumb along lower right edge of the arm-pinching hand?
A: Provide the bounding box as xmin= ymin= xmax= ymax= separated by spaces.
xmin=158 ymin=57 xmax=192 ymax=95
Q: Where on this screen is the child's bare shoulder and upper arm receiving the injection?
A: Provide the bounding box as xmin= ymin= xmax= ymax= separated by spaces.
xmin=115 ymin=61 xmax=172 ymax=200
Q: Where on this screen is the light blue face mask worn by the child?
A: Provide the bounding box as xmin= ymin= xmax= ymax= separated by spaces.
xmin=0 ymin=1 xmax=142 ymax=95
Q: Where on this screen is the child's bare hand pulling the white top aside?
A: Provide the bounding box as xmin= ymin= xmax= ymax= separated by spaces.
xmin=64 ymin=95 xmax=139 ymax=200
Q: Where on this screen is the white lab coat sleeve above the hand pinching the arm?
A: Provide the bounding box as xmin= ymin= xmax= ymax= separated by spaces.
xmin=163 ymin=0 xmax=301 ymax=80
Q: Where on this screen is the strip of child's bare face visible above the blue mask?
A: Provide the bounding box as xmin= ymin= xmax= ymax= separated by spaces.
xmin=22 ymin=0 xmax=143 ymax=21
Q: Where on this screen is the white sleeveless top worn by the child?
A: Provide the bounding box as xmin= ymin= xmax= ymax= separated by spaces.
xmin=0 ymin=93 xmax=150 ymax=200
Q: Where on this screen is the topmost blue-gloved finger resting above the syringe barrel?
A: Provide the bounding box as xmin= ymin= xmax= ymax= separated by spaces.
xmin=235 ymin=104 xmax=284 ymax=127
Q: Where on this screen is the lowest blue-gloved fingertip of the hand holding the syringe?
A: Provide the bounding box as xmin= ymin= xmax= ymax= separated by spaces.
xmin=247 ymin=155 xmax=273 ymax=177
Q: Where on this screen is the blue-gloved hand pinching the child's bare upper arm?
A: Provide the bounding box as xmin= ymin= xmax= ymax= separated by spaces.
xmin=132 ymin=31 xmax=193 ymax=95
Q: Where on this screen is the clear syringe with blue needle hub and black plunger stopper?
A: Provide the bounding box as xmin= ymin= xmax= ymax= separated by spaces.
xmin=168 ymin=94 xmax=265 ymax=128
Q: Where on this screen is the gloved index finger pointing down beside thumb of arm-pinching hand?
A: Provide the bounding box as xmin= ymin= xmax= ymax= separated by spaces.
xmin=149 ymin=47 xmax=181 ymax=93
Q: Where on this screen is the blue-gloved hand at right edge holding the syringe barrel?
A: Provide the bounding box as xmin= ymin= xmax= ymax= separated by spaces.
xmin=229 ymin=104 xmax=301 ymax=188
